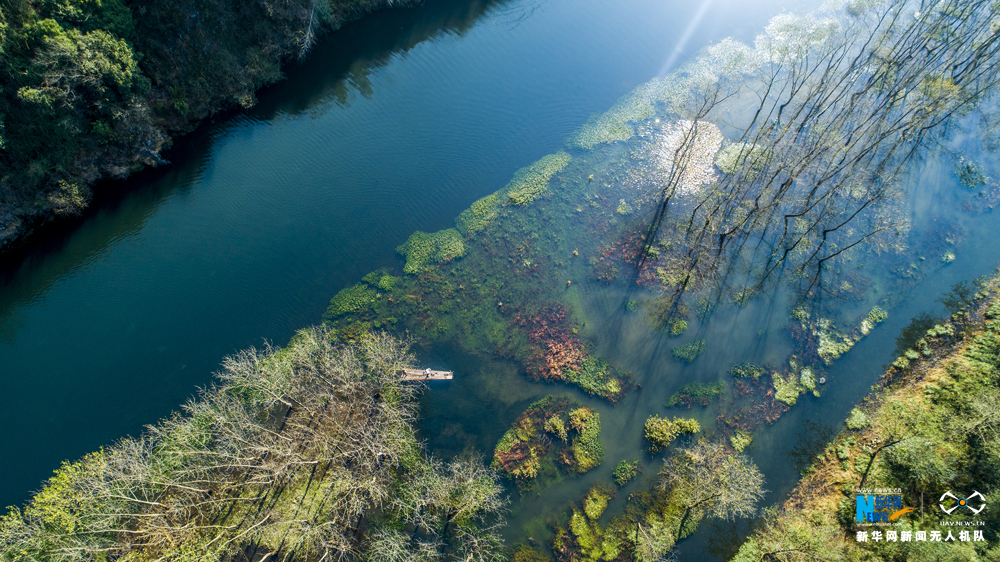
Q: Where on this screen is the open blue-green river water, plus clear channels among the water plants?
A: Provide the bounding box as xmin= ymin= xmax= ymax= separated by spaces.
xmin=0 ymin=0 xmax=1000 ymax=556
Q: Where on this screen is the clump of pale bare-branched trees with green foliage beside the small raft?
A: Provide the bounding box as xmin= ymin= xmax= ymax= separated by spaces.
xmin=0 ymin=329 xmax=504 ymax=562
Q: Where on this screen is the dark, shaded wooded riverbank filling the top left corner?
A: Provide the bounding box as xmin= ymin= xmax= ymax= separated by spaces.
xmin=0 ymin=0 xmax=413 ymax=252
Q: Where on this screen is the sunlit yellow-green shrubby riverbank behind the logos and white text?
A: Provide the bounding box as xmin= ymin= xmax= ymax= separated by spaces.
xmin=733 ymin=276 xmax=1000 ymax=562
